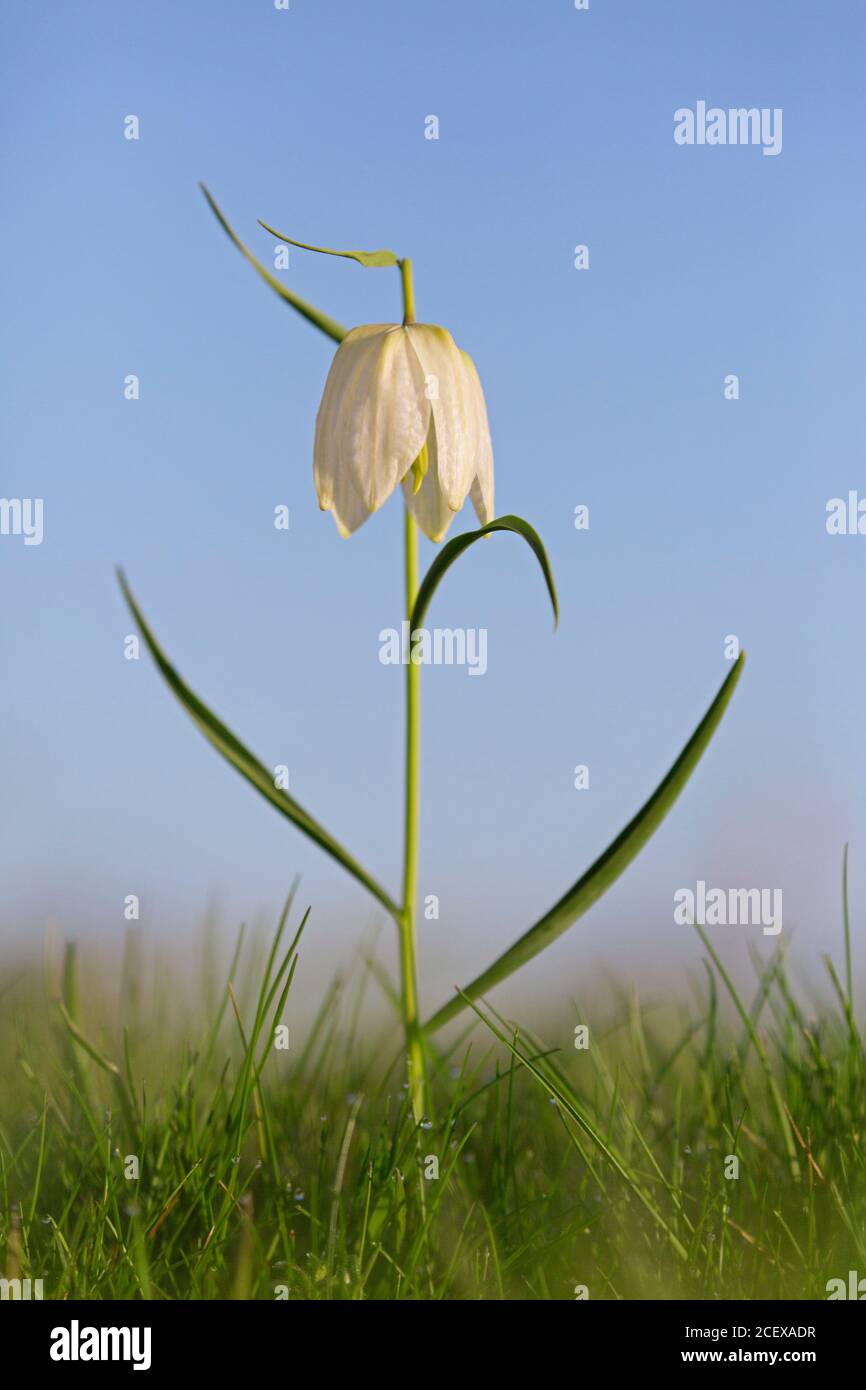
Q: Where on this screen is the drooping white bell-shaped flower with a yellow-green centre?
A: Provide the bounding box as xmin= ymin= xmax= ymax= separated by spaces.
xmin=313 ymin=324 xmax=493 ymax=541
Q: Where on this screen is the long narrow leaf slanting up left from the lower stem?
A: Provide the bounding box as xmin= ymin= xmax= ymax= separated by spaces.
xmin=118 ymin=570 xmax=400 ymax=917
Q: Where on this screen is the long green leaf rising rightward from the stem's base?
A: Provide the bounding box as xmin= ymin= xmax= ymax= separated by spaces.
xmin=424 ymin=652 xmax=745 ymax=1033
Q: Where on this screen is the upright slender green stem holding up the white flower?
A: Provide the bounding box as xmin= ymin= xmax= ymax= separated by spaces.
xmin=398 ymin=252 xmax=427 ymax=1123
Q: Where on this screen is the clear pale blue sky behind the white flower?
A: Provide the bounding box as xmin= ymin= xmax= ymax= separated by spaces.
xmin=0 ymin=0 xmax=866 ymax=1002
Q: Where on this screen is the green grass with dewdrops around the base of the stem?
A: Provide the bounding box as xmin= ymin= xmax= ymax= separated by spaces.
xmin=0 ymin=884 xmax=866 ymax=1300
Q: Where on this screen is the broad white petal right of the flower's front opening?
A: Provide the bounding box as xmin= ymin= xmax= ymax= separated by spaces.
xmin=406 ymin=324 xmax=480 ymax=512
